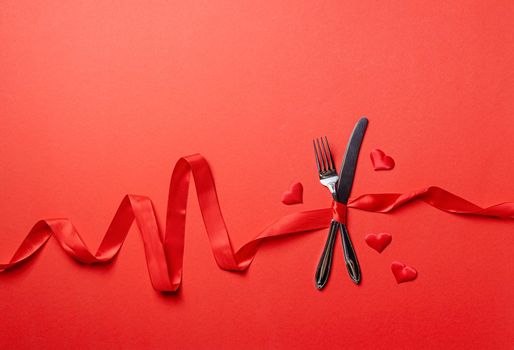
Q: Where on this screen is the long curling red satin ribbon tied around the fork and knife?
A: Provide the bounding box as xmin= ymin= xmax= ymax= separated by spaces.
xmin=0 ymin=154 xmax=514 ymax=292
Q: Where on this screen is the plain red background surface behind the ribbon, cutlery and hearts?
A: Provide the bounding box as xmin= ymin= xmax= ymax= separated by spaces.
xmin=0 ymin=1 xmax=514 ymax=349
